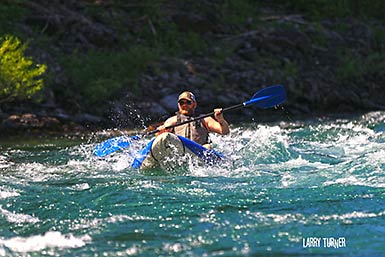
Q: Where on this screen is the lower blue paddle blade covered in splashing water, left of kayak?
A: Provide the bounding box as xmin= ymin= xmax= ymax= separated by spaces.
xmin=94 ymin=136 xmax=141 ymax=157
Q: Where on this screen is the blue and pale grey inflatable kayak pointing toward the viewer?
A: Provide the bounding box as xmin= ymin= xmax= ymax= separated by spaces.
xmin=132 ymin=132 xmax=224 ymax=170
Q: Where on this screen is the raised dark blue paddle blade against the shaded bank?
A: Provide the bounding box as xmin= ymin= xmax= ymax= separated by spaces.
xmin=243 ymin=85 xmax=286 ymax=109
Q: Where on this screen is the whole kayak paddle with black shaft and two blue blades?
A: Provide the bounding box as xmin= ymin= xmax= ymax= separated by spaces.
xmin=94 ymin=85 xmax=286 ymax=157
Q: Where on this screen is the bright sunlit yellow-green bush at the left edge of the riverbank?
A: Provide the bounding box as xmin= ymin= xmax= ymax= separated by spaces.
xmin=0 ymin=36 xmax=47 ymax=102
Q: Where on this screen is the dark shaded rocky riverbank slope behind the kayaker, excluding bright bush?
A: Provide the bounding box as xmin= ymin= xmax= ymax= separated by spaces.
xmin=0 ymin=0 xmax=385 ymax=134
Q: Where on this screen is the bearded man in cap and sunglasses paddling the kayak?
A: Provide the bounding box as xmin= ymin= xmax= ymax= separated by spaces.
xmin=158 ymin=91 xmax=230 ymax=148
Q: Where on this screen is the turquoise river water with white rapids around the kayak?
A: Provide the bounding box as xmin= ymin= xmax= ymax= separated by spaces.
xmin=0 ymin=112 xmax=385 ymax=256
